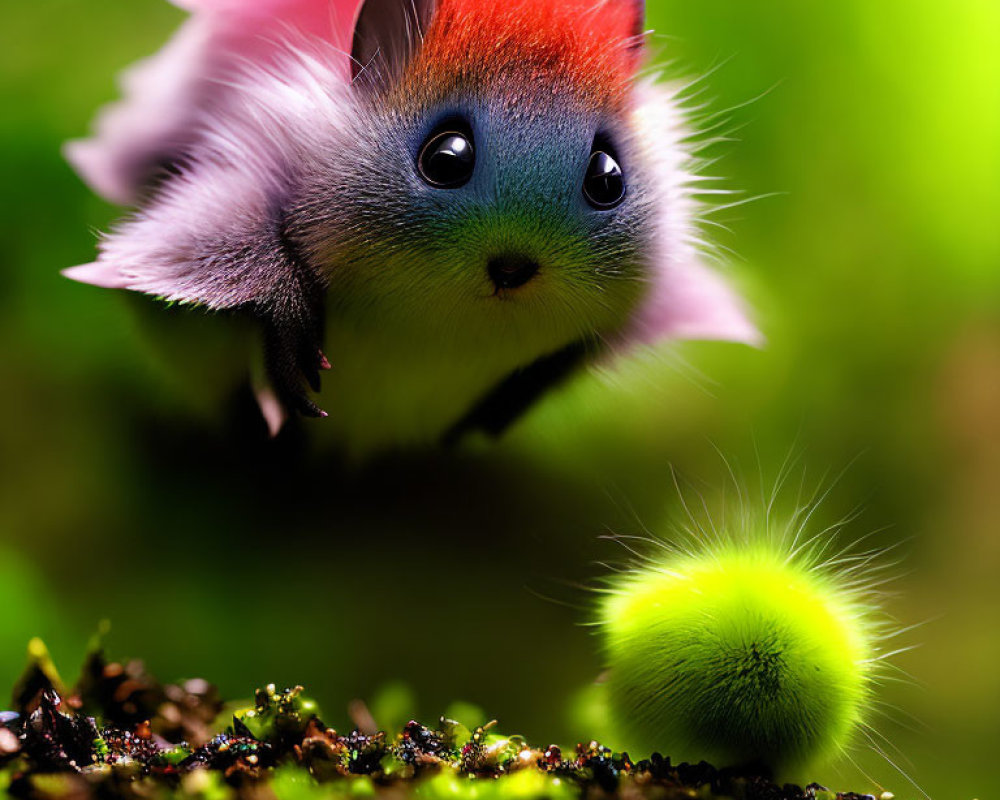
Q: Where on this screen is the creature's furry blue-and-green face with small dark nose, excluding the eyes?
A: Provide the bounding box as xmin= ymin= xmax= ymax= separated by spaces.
xmin=288 ymin=84 xmax=651 ymax=351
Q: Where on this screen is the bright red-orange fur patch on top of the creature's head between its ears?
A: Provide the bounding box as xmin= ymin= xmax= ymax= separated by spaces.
xmin=402 ymin=0 xmax=643 ymax=104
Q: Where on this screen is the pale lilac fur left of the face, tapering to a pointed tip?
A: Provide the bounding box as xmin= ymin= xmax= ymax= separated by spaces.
xmin=65 ymin=45 xmax=351 ymax=309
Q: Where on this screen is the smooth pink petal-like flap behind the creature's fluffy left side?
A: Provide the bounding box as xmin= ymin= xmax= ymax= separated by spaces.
xmin=65 ymin=0 xmax=362 ymax=205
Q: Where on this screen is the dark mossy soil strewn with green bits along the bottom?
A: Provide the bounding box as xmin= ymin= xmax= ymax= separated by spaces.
xmin=0 ymin=642 xmax=892 ymax=800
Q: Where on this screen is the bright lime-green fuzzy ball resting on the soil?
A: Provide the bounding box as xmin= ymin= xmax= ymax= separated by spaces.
xmin=600 ymin=542 xmax=874 ymax=776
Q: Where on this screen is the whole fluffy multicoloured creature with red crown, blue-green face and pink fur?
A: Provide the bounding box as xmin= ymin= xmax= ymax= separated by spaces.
xmin=67 ymin=0 xmax=757 ymax=450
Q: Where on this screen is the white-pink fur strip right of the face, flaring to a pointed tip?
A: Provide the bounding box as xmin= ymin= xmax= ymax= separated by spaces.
xmin=626 ymin=82 xmax=763 ymax=345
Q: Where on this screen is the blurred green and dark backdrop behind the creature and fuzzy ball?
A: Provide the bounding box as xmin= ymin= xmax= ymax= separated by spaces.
xmin=0 ymin=0 xmax=1000 ymax=798
